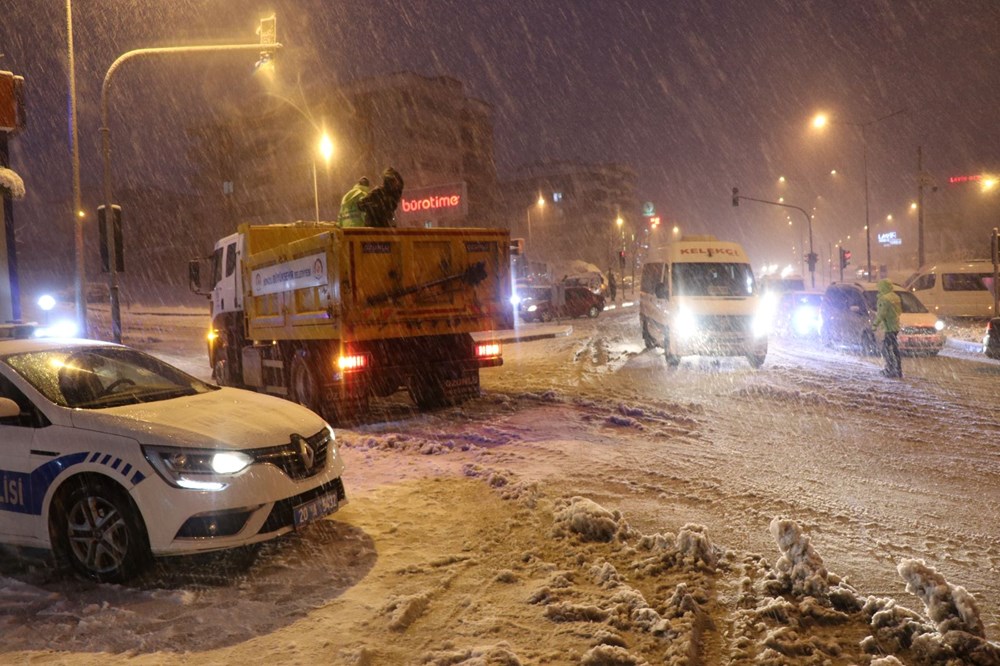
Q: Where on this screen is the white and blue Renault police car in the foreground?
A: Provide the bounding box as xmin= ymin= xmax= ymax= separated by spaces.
xmin=0 ymin=331 xmax=346 ymax=582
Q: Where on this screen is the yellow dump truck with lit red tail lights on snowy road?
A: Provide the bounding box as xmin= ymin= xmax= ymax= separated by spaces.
xmin=190 ymin=222 xmax=513 ymax=422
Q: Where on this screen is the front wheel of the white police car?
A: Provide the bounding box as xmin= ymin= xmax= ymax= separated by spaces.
xmin=51 ymin=477 xmax=152 ymax=583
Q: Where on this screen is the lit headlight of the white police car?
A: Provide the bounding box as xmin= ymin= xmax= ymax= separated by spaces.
xmin=142 ymin=446 xmax=253 ymax=490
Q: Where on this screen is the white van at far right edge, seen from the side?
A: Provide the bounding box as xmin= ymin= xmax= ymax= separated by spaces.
xmin=904 ymin=260 xmax=993 ymax=319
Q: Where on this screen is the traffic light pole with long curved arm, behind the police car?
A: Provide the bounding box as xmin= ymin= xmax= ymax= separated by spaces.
xmin=101 ymin=35 xmax=281 ymax=343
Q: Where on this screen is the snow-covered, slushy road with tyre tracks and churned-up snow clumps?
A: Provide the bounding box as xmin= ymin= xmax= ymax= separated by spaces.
xmin=0 ymin=307 xmax=1000 ymax=666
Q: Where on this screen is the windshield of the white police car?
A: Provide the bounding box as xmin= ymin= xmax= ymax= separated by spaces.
xmin=2 ymin=346 xmax=218 ymax=409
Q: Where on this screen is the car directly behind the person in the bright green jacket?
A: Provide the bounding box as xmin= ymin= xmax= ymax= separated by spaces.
xmin=820 ymin=282 xmax=944 ymax=356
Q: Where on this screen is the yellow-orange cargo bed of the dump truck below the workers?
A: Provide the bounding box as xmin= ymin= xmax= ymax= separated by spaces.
xmin=241 ymin=224 xmax=511 ymax=341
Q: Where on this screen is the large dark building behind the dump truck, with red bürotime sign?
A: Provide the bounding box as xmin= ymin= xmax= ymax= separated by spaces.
xmin=193 ymin=72 xmax=500 ymax=235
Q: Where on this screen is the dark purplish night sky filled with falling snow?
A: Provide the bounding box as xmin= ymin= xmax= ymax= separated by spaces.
xmin=0 ymin=0 xmax=1000 ymax=282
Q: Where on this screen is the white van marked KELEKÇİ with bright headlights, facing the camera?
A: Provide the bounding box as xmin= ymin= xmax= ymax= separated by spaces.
xmin=639 ymin=236 xmax=767 ymax=368
